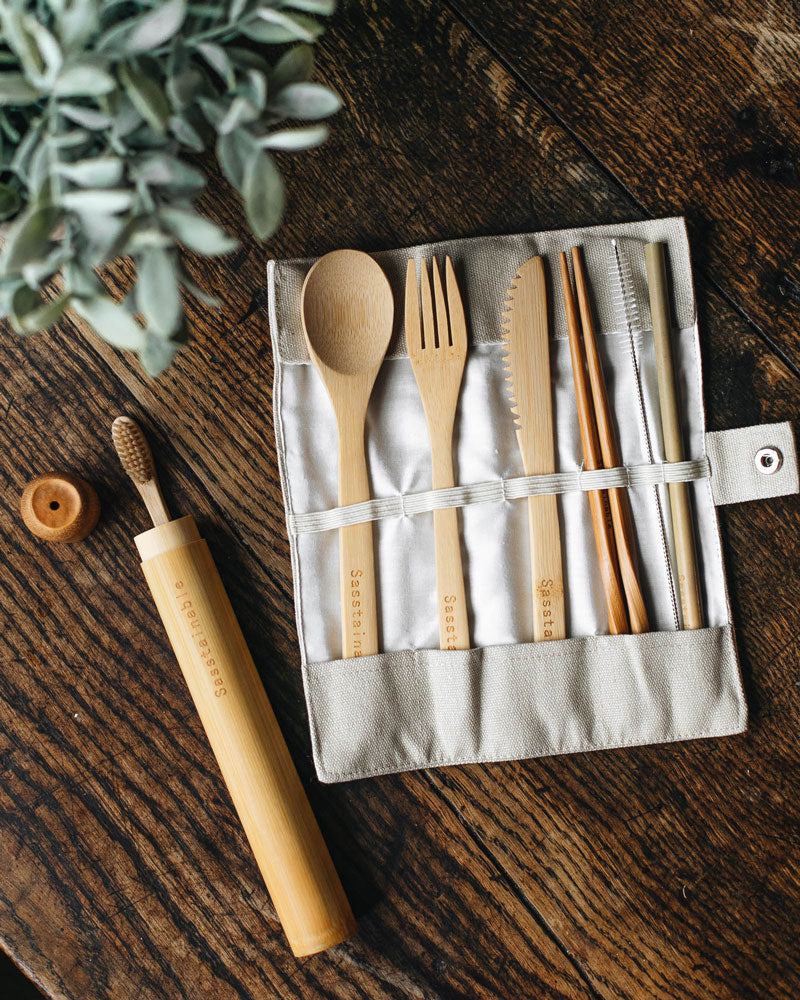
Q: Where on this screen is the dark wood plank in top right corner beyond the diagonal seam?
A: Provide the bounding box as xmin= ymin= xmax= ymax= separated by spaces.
xmin=452 ymin=0 xmax=800 ymax=374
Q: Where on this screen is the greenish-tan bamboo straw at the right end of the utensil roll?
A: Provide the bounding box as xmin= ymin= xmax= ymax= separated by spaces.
xmin=644 ymin=243 xmax=703 ymax=629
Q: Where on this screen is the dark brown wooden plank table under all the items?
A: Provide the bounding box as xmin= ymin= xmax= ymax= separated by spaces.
xmin=0 ymin=0 xmax=800 ymax=1000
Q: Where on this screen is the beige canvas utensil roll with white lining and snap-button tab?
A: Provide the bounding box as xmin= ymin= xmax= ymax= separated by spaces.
xmin=267 ymin=219 xmax=798 ymax=781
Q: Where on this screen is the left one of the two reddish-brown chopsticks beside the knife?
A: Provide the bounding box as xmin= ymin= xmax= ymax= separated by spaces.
xmin=559 ymin=251 xmax=630 ymax=635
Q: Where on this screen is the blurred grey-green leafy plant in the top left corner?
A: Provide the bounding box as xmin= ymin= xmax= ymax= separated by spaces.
xmin=0 ymin=0 xmax=340 ymax=375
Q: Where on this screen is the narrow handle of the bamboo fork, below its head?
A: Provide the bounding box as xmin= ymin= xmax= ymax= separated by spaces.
xmin=432 ymin=440 xmax=469 ymax=649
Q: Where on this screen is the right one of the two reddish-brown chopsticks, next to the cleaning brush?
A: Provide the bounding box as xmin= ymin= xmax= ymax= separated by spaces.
xmin=572 ymin=247 xmax=650 ymax=634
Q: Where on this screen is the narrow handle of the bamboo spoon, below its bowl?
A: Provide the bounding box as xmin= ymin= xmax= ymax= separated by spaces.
xmin=339 ymin=422 xmax=378 ymax=659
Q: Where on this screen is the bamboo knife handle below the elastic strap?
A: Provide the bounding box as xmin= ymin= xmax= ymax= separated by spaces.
xmin=528 ymin=494 xmax=567 ymax=642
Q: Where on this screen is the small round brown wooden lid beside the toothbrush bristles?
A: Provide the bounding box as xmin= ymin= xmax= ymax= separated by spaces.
xmin=20 ymin=472 xmax=100 ymax=542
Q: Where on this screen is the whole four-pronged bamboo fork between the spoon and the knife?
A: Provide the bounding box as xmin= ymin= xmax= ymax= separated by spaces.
xmin=406 ymin=257 xmax=469 ymax=649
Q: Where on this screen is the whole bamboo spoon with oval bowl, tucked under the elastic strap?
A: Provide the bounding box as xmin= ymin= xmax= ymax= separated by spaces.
xmin=301 ymin=250 xmax=394 ymax=657
